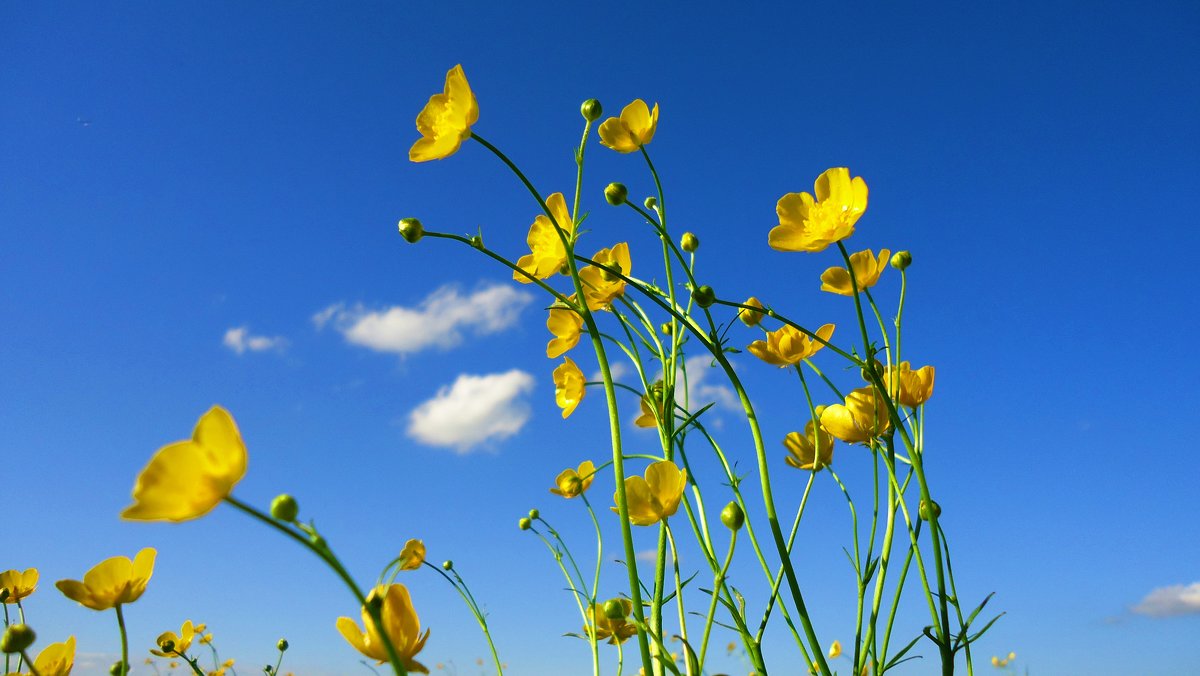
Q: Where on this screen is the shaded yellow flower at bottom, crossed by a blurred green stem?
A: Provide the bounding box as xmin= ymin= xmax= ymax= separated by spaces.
xmin=337 ymin=585 xmax=430 ymax=674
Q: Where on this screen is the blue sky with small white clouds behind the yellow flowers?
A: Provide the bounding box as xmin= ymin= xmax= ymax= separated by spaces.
xmin=0 ymin=2 xmax=1200 ymax=675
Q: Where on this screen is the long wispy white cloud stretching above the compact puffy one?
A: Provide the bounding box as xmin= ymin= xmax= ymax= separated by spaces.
xmin=312 ymin=285 xmax=533 ymax=354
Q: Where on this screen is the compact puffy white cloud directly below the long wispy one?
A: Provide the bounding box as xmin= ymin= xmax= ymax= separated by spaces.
xmin=408 ymin=369 xmax=534 ymax=454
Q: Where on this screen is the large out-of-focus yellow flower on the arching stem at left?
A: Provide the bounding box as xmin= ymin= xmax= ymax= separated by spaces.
xmin=121 ymin=406 xmax=246 ymax=521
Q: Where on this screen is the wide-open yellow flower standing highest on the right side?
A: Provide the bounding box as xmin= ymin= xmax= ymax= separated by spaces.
xmin=768 ymin=167 xmax=866 ymax=252
